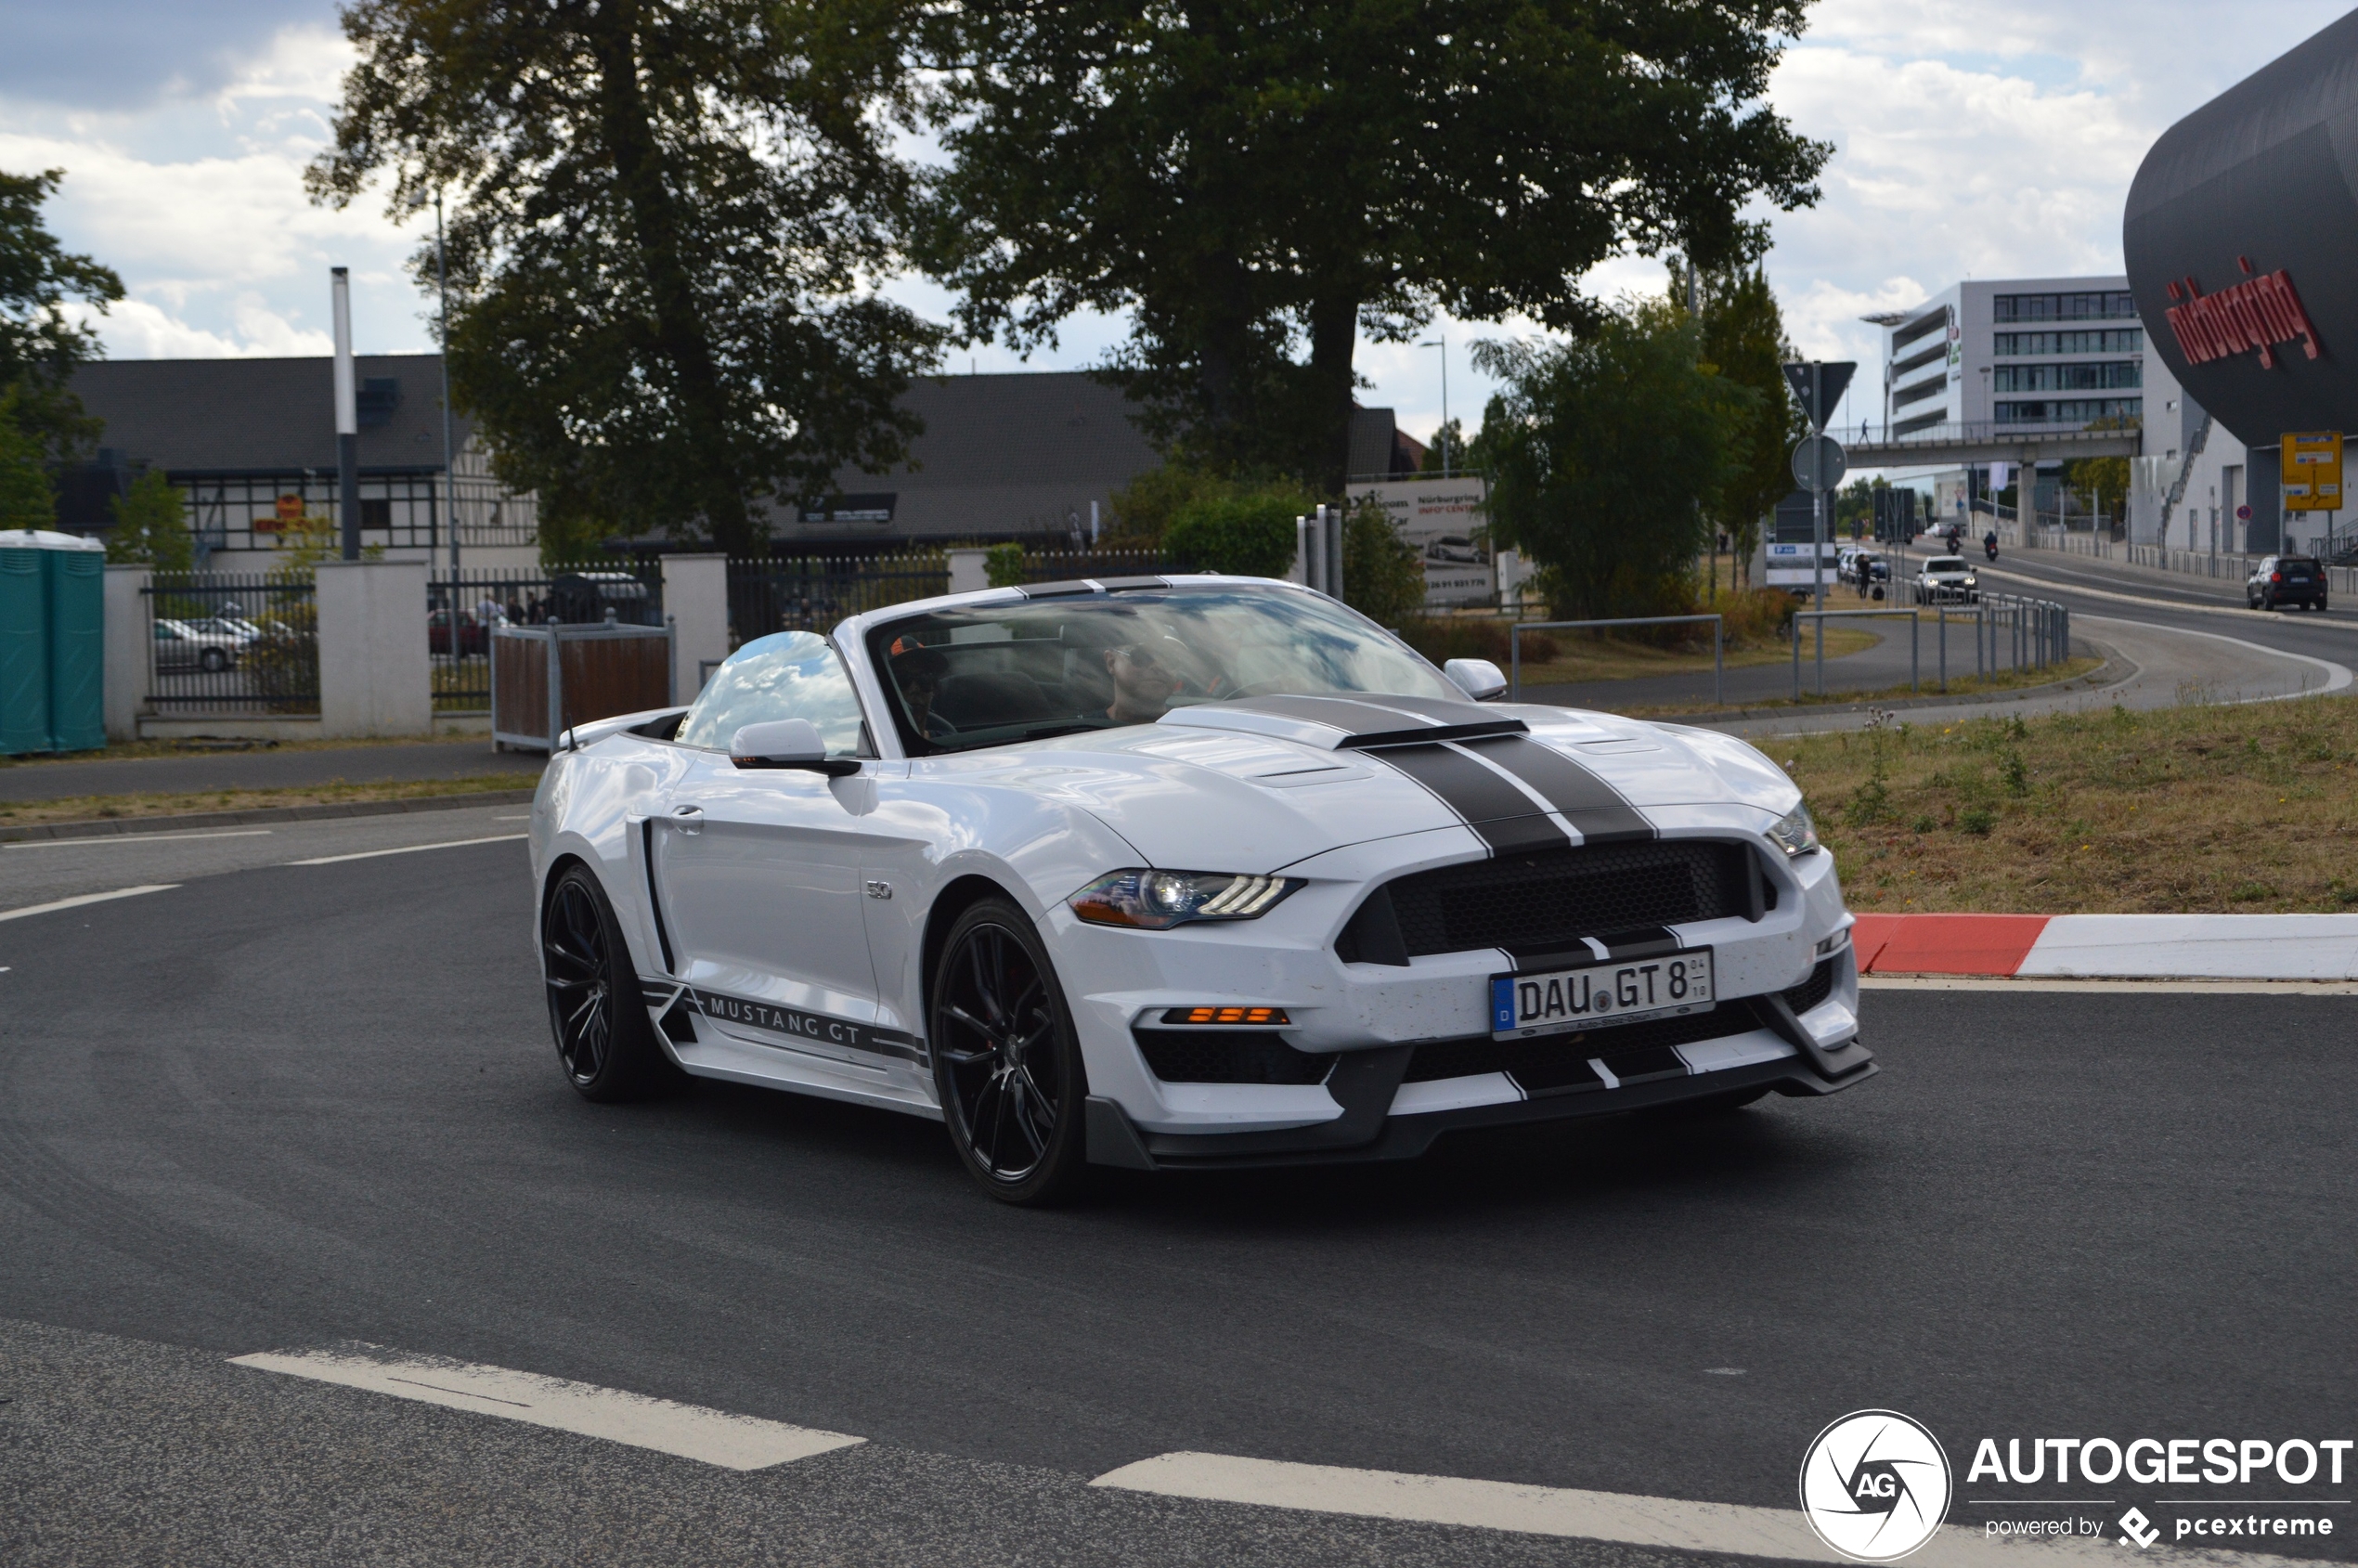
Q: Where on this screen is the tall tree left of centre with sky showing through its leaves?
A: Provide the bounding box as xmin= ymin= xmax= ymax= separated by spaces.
xmin=306 ymin=0 xmax=940 ymax=554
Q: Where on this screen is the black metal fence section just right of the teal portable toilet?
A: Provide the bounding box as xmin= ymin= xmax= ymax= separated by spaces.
xmin=141 ymin=571 xmax=318 ymax=715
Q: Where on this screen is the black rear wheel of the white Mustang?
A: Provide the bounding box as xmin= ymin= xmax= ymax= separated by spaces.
xmin=540 ymin=865 xmax=669 ymax=1101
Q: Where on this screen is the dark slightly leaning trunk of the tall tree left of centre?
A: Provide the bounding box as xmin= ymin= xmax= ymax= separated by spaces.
xmin=590 ymin=0 xmax=757 ymax=554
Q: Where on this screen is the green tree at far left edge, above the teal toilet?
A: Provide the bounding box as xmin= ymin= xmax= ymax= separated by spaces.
xmin=0 ymin=170 xmax=123 ymax=462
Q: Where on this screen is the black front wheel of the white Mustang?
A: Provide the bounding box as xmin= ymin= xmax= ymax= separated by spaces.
xmin=931 ymin=899 xmax=1089 ymax=1202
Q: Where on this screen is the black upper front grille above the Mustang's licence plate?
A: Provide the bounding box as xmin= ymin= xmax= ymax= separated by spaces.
xmin=1377 ymin=839 xmax=1766 ymax=962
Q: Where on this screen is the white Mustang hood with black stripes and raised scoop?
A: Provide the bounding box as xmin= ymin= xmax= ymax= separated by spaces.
xmin=917 ymin=698 xmax=1799 ymax=873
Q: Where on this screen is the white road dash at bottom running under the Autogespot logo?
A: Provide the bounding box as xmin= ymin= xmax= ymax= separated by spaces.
xmin=1089 ymin=1453 xmax=2315 ymax=1568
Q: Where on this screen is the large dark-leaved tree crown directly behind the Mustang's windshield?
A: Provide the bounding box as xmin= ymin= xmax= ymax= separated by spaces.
xmin=913 ymin=0 xmax=1830 ymax=495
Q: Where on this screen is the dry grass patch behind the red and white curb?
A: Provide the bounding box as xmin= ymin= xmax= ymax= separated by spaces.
xmin=1764 ymin=698 xmax=2358 ymax=914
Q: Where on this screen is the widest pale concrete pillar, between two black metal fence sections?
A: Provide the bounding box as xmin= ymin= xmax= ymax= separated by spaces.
xmin=318 ymin=561 xmax=434 ymax=741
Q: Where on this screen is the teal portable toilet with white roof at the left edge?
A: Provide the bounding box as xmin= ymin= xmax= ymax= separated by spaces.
xmin=0 ymin=528 xmax=106 ymax=755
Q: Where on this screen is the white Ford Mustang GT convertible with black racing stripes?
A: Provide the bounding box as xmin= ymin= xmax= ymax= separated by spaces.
xmin=531 ymin=576 xmax=1874 ymax=1202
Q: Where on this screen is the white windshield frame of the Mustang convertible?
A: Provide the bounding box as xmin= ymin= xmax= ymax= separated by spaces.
xmin=858 ymin=573 xmax=1471 ymax=759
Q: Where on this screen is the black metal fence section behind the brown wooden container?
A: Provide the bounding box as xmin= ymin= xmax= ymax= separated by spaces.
xmin=427 ymin=561 xmax=663 ymax=712
